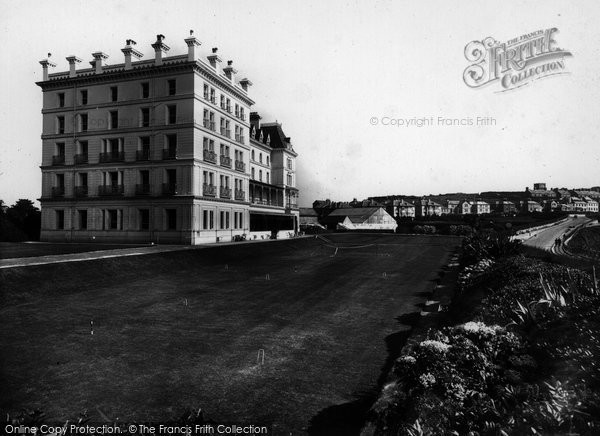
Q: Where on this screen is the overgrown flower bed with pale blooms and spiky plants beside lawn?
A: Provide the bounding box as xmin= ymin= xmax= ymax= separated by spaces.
xmin=364 ymin=233 xmax=600 ymax=435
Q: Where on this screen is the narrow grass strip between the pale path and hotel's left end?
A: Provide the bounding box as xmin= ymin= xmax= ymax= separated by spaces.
xmin=0 ymin=242 xmax=149 ymax=259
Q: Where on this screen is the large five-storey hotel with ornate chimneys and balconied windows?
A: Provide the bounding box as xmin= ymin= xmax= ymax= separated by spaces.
xmin=37 ymin=32 xmax=299 ymax=244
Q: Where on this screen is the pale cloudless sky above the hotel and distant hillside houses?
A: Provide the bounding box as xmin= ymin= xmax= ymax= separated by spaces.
xmin=0 ymin=0 xmax=600 ymax=206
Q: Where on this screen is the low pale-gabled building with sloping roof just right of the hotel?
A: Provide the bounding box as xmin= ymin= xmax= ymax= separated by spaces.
xmin=322 ymin=207 xmax=398 ymax=231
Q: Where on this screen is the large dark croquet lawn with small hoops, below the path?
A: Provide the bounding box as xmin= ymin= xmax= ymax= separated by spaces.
xmin=0 ymin=234 xmax=459 ymax=436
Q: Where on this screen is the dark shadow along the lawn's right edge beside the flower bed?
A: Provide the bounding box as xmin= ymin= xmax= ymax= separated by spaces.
xmin=308 ymin=312 xmax=421 ymax=436
